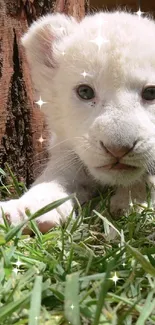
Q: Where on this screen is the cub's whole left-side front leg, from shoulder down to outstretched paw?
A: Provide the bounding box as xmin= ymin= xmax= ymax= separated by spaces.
xmin=0 ymin=152 xmax=93 ymax=232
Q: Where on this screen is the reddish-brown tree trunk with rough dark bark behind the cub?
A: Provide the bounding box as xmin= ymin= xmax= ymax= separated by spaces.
xmin=0 ymin=0 xmax=88 ymax=190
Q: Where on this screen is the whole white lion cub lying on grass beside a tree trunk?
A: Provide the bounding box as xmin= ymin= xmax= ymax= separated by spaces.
xmin=0 ymin=11 xmax=155 ymax=232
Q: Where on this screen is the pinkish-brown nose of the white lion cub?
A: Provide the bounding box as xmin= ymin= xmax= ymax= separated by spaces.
xmin=100 ymin=141 xmax=135 ymax=158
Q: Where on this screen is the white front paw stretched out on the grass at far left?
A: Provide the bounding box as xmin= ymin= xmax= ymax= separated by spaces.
xmin=0 ymin=184 xmax=73 ymax=234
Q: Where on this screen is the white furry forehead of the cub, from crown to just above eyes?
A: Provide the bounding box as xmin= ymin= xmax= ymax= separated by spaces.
xmin=57 ymin=12 xmax=155 ymax=82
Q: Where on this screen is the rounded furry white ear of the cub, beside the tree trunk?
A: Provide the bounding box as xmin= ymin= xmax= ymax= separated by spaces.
xmin=21 ymin=14 xmax=78 ymax=88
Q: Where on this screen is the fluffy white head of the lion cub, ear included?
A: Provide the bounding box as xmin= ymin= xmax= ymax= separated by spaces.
xmin=24 ymin=12 xmax=155 ymax=185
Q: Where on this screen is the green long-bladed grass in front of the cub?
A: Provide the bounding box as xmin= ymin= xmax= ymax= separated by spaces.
xmin=0 ymin=166 xmax=155 ymax=325
